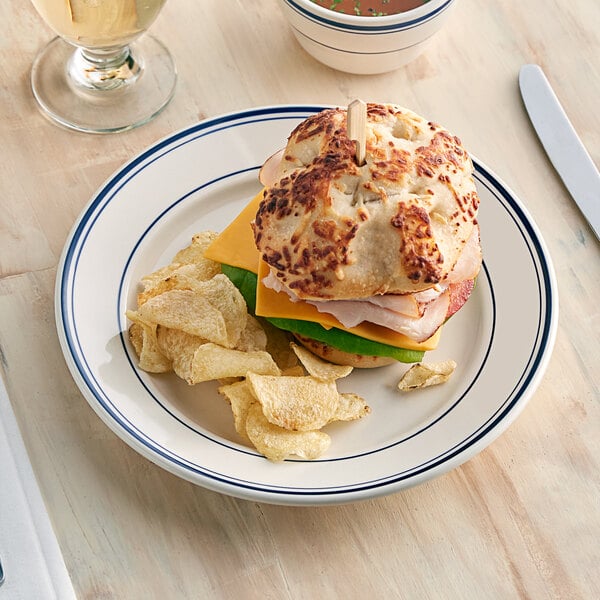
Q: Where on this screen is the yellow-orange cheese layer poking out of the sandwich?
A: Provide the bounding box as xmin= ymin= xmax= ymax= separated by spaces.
xmin=204 ymin=191 xmax=441 ymax=351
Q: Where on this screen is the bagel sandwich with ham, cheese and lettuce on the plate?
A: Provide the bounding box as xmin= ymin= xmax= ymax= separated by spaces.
xmin=206 ymin=103 xmax=482 ymax=367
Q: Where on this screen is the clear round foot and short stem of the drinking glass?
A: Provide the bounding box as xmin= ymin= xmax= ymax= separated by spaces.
xmin=31 ymin=34 xmax=177 ymax=133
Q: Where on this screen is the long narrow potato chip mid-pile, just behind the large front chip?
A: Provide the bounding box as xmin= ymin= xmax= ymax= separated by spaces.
xmin=186 ymin=343 xmax=279 ymax=384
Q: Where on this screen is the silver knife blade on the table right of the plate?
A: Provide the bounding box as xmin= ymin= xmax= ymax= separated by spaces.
xmin=519 ymin=65 xmax=600 ymax=239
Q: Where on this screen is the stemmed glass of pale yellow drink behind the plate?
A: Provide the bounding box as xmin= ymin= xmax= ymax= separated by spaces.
xmin=31 ymin=0 xmax=177 ymax=133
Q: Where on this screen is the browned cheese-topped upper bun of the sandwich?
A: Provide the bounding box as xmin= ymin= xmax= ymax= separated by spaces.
xmin=253 ymin=103 xmax=481 ymax=300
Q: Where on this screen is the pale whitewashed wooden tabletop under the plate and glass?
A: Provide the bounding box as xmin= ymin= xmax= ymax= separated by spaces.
xmin=0 ymin=0 xmax=600 ymax=599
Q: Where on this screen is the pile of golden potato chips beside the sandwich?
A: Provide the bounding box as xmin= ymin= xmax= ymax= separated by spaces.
xmin=127 ymin=232 xmax=370 ymax=461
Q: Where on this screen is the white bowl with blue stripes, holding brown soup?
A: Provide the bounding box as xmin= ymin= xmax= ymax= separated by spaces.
xmin=280 ymin=0 xmax=455 ymax=75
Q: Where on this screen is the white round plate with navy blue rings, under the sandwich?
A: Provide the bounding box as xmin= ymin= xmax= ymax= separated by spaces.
xmin=56 ymin=105 xmax=558 ymax=505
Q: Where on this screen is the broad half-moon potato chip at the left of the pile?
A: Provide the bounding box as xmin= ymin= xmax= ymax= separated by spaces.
xmin=138 ymin=290 xmax=229 ymax=346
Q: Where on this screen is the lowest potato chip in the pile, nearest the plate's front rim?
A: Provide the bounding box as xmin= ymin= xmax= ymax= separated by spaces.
xmin=246 ymin=403 xmax=331 ymax=462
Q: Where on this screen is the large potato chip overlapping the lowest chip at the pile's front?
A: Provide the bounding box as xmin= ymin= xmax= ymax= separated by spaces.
xmin=247 ymin=372 xmax=338 ymax=431
